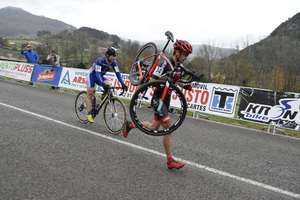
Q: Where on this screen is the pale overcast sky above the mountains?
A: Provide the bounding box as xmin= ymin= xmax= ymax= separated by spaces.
xmin=0 ymin=0 xmax=300 ymax=47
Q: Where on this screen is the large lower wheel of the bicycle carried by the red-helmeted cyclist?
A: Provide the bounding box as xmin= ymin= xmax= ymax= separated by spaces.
xmin=129 ymin=80 xmax=187 ymax=136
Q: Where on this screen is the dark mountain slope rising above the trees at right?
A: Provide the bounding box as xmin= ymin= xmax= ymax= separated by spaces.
xmin=231 ymin=13 xmax=300 ymax=74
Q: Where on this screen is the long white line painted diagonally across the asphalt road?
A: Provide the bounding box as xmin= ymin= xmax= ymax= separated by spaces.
xmin=0 ymin=102 xmax=300 ymax=199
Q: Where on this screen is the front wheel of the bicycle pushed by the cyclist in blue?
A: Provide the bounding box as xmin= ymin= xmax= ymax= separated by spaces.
xmin=103 ymin=97 xmax=126 ymax=135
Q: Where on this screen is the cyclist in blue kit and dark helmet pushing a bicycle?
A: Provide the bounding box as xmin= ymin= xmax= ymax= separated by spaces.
xmin=86 ymin=47 xmax=127 ymax=123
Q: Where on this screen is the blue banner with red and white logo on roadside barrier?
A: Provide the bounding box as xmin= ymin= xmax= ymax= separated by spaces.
xmin=31 ymin=65 xmax=62 ymax=86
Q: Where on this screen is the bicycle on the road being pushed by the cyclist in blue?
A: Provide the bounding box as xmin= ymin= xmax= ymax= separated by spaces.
xmin=75 ymin=86 xmax=126 ymax=135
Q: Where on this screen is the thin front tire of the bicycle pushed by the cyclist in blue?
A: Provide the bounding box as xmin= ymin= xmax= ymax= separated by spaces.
xmin=103 ymin=97 xmax=126 ymax=135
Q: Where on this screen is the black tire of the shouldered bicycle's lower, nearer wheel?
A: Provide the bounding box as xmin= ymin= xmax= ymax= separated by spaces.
xmin=129 ymin=80 xmax=187 ymax=136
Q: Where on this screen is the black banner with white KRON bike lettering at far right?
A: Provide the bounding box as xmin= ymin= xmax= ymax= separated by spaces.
xmin=238 ymin=88 xmax=300 ymax=128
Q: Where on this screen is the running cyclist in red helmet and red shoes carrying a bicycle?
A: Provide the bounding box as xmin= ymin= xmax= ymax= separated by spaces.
xmin=122 ymin=40 xmax=192 ymax=169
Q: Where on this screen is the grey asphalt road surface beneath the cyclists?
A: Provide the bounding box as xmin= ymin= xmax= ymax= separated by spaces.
xmin=0 ymin=80 xmax=300 ymax=200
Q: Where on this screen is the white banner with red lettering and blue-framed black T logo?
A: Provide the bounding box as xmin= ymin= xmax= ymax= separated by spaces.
xmin=108 ymin=76 xmax=239 ymax=117
